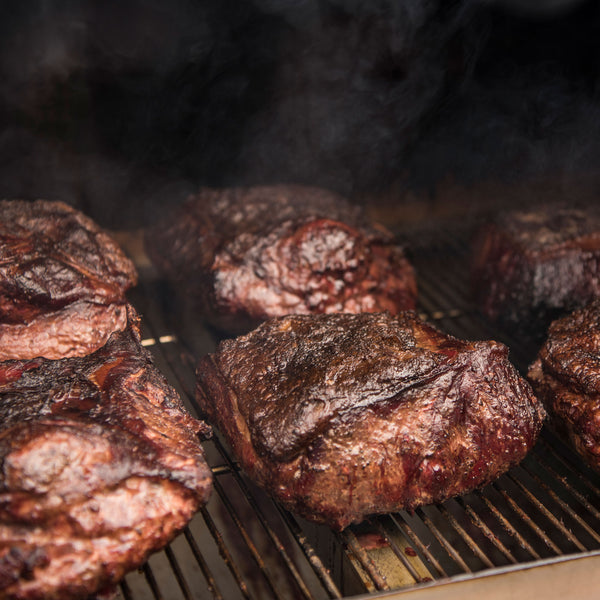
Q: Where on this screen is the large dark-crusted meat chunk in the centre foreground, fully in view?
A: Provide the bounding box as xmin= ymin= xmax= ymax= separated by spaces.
xmin=197 ymin=312 xmax=545 ymax=530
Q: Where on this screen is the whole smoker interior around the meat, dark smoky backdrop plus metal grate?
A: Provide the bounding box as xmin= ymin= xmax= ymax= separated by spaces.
xmin=0 ymin=0 xmax=600 ymax=600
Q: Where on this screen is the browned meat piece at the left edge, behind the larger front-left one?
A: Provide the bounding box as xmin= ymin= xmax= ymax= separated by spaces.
xmin=0 ymin=200 xmax=137 ymax=360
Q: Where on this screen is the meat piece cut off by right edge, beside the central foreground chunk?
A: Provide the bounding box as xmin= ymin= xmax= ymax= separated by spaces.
xmin=529 ymin=300 xmax=600 ymax=471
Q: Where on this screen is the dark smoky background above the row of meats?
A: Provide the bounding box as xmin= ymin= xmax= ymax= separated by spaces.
xmin=0 ymin=0 xmax=600 ymax=229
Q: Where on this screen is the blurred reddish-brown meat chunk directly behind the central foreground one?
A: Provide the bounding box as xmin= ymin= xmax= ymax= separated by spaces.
xmin=146 ymin=185 xmax=417 ymax=332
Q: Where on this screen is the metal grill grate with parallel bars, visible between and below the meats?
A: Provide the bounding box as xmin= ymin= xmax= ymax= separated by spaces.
xmin=109 ymin=228 xmax=600 ymax=600
